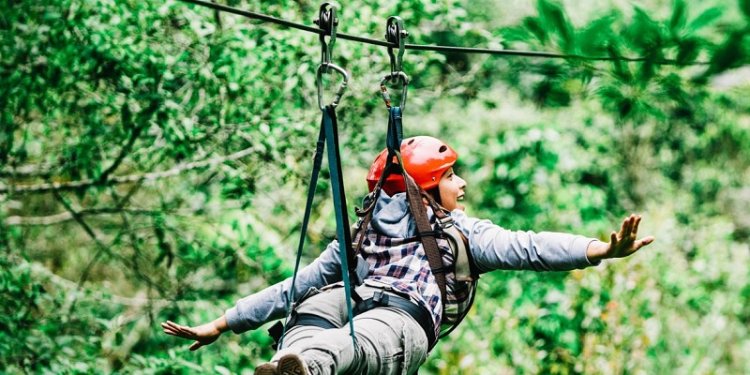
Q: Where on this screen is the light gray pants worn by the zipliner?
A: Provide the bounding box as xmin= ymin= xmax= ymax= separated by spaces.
xmin=273 ymin=285 xmax=428 ymax=374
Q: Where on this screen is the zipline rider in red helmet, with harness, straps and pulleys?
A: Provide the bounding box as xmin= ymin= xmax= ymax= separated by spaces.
xmin=161 ymin=3 xmax=654 ymax=375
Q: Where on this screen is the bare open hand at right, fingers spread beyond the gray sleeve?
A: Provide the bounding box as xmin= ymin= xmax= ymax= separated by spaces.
xmin=586 ymin=214 xmax=654 ymax=262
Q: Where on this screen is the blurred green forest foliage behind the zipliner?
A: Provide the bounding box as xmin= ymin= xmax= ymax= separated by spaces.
xmin=0 ymin=0 xmax=750 ymax=374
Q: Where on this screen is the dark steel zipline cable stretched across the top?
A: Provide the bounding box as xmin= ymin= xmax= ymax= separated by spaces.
xmin=180 ymin=0 xmax=708 ymax=65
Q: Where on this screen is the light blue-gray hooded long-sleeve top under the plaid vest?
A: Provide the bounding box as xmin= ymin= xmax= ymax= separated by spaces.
xmin=225 ymin=193 xmax=598 ymax=333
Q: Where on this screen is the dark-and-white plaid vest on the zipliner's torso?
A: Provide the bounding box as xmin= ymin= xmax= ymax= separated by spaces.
xmin=355 ymin=222 xmax=472 ymax=337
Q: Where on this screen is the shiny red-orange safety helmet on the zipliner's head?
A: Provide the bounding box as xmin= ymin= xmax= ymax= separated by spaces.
xmin=367 ymin=136 xmax=458 ymax=195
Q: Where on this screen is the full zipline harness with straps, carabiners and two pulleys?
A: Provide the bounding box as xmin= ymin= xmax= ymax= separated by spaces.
xmin=269 ymin=3 xmax=479 ymax=349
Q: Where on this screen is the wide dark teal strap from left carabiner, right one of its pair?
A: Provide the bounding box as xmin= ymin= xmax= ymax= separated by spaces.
xmin=323 ymin=105 xmax=357 ymax=347
